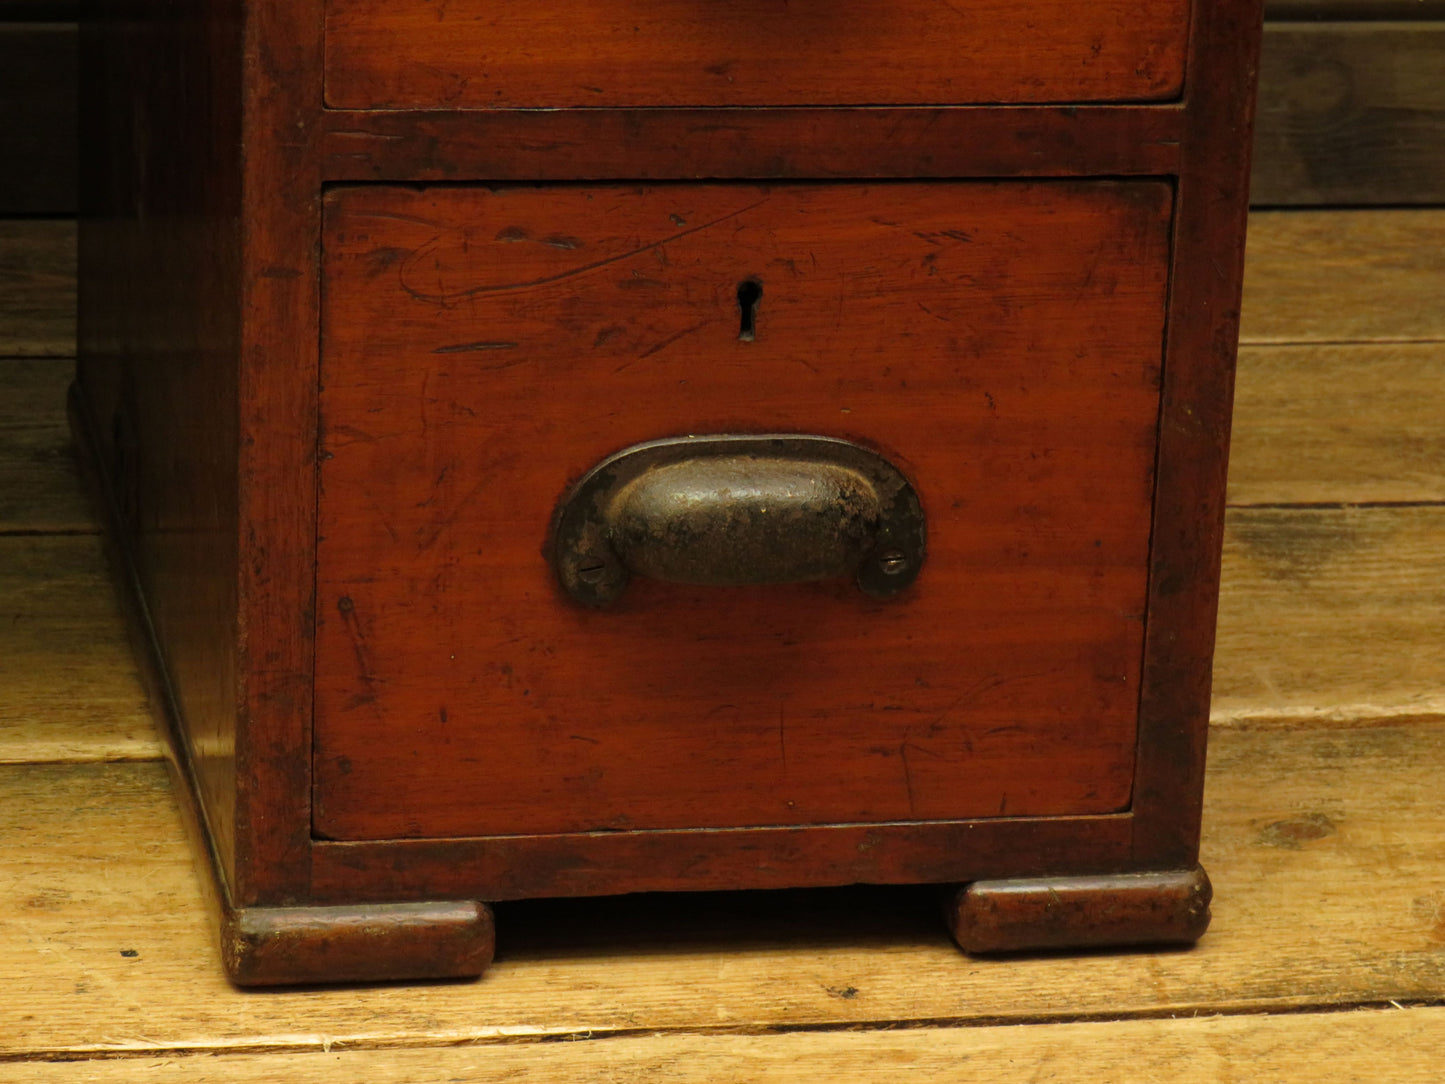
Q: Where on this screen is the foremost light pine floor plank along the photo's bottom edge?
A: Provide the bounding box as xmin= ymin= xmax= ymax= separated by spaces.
xmin=6 ymin=1007 xmax=1445 ymax=1084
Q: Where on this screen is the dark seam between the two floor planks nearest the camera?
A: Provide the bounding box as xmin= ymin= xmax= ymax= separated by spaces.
xmin=0 ymin=993 xmax=1445 ymax=1065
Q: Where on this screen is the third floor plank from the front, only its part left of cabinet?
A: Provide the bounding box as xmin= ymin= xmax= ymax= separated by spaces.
xmin=0 ymin=535 xmax=160 ymax=763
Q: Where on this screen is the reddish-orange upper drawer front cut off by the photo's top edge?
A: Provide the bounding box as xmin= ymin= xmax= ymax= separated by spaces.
xmin=327 ymin=0 xmax=1189 ymax=108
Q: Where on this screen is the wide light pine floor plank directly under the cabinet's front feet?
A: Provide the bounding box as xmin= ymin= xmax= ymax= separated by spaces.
xmin=0 ymin=723 xmax=1445 ymax=1057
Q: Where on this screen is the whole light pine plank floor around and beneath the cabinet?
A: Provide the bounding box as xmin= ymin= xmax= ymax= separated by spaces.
xmin=0 ymin=211 xmax=1445 ymax=1084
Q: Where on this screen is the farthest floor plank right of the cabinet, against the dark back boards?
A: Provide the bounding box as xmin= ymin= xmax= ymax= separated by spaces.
xmin=1240 ymin=210 xmax=1445 ymax=343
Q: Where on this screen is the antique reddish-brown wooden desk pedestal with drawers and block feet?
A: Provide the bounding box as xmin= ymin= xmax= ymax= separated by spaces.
xmin=72 ymin=0 xmax=1260 ymax=984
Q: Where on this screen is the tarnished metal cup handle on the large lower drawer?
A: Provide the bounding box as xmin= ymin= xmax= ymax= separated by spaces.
xmin=551 ymin=435 xmax=925 ymax=606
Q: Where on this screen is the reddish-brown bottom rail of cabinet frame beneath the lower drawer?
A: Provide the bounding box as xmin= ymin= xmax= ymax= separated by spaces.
xmin=311 ymin=812 xmax=1140 ymax=903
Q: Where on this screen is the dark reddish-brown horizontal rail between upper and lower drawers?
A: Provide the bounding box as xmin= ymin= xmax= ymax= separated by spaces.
xmin=322 ymin=106 xmax=1185 ymax=182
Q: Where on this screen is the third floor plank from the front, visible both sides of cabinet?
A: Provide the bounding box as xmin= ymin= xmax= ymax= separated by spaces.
xmin=0 ymin=506 xmax=1445 ymax=763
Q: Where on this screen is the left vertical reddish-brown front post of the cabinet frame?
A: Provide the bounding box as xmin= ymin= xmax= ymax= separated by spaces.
xmin=233 ymin=0 xmax=322 ymax=906
